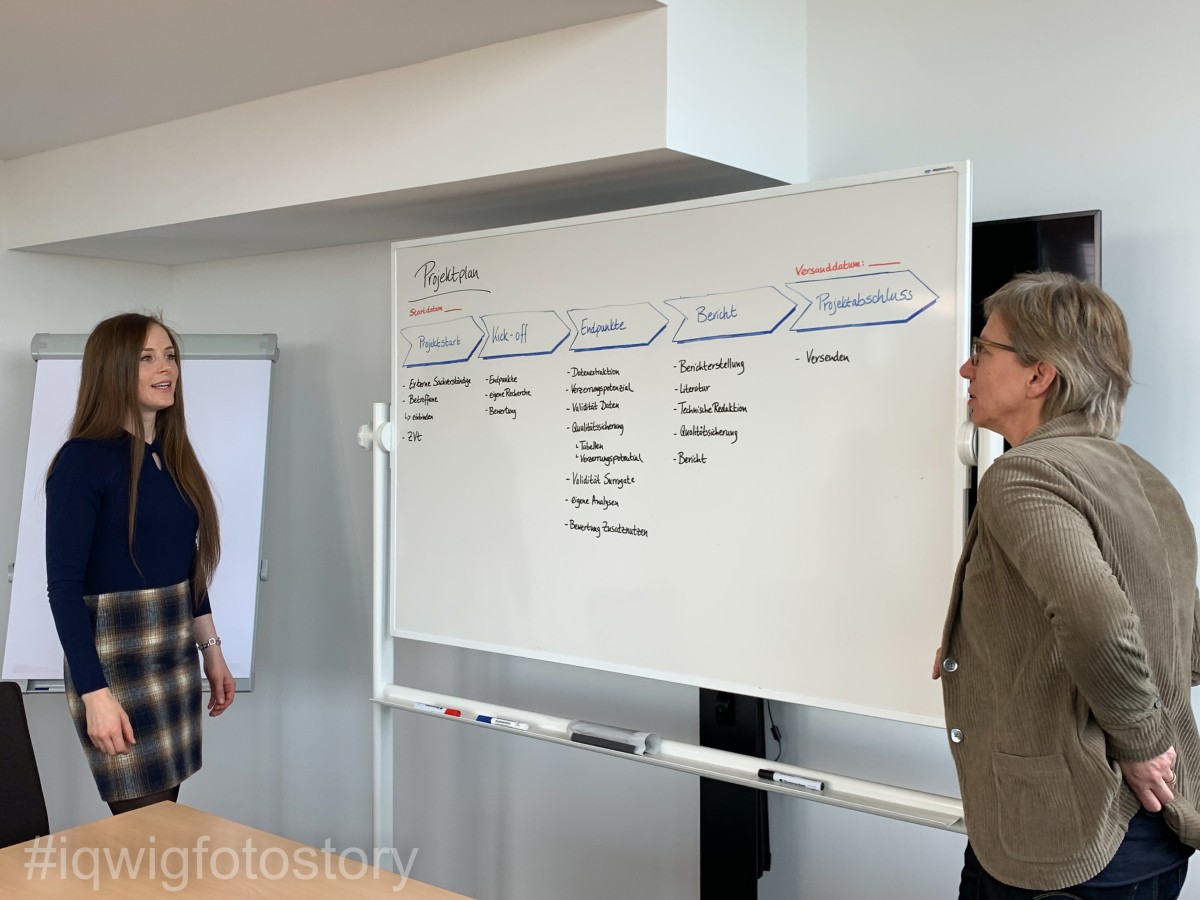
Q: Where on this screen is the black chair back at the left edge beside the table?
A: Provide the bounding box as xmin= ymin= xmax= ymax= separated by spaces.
xmin=0 ymin=682 xmax=50 ymax=847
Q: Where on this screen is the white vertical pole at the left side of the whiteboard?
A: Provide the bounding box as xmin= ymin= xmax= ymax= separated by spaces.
xmin=359 ymin=403 xmax=396 ymax=865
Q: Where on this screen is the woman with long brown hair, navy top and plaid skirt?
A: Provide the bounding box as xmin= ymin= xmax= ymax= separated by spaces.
xmin=46 ymin=313 xmax=234 ymax=814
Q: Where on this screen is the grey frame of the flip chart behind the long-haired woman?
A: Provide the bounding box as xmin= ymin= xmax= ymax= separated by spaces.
xmin=10 ymin=332 xmax=280 ymax=694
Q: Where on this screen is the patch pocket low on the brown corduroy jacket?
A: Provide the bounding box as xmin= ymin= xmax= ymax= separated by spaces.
xmin=991 ymin=752 xmax=1086 ymax=863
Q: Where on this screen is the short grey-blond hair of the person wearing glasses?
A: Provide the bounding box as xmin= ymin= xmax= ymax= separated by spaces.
xmin=983 ymin=272 xmax=1133 ymax=438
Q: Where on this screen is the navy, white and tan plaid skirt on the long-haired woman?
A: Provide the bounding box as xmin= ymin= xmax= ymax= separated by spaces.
xmin=62 ymin=581 xmax=202 ymax=802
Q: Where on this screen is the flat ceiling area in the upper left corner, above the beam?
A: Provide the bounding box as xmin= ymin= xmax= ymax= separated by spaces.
xmin=0 ymin=0 xmax=662 ymax=160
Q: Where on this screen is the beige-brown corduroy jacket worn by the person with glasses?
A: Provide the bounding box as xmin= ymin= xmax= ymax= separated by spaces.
xmin=942 ymin=413 xmax=1200 ymax=889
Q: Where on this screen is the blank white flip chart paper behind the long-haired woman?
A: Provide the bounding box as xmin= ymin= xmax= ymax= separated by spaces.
xmin=2 ymin=352 xmax=272 ymax=686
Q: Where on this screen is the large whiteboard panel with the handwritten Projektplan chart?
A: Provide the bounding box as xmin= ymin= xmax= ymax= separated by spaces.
xmin=391 ymin=163 xmax=970 ymax=725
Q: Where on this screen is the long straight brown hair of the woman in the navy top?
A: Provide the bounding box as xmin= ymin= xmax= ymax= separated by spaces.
xmin=49 ymin=312 xmax=221 ymax=607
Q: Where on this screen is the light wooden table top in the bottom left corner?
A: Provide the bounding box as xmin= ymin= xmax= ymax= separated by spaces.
xmin=0 ymin=803 xmax=462 ymax=900
